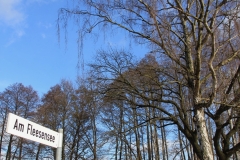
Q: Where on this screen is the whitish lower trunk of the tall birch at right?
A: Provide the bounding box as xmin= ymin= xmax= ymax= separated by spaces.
xmin=195 ymin=108 xmax=213 ymax=160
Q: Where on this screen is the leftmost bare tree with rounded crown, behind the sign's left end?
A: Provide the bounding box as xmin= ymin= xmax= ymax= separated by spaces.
xmin=0 ymin=83 xmax=39 ymax=160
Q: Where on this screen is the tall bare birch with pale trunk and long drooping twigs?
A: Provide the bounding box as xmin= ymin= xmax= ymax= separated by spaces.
xmin=59 ymin=0 xmax=239 ymax=159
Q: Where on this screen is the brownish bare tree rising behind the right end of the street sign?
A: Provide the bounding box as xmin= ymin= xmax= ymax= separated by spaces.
xmin=37 ymin=80 xmax=75 ymax=160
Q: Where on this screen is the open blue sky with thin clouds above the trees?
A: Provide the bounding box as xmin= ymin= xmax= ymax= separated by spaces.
xmin=0 ymin=0 xmax=144 ymax=95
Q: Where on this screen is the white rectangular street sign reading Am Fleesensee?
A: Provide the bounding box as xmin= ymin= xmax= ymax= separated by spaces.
xmin=6 ymin=113 xmax=62 ymax=148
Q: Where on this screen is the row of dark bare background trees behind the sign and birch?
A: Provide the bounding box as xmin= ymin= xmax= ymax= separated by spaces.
xmin=0 ymin=49 xmax=240 ymax=160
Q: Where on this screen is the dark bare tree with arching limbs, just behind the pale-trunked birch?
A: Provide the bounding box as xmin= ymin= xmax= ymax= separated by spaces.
xmin=87 ymin=44 xmax=239 ymax=159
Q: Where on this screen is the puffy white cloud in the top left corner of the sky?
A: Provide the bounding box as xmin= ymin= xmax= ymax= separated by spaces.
xmin=0 ymin=0 xmax=26 ymax=28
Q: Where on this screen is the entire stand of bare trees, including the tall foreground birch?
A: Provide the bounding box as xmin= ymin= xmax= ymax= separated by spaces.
xmin=0 ymin=0 xmax=240 ymax=160
